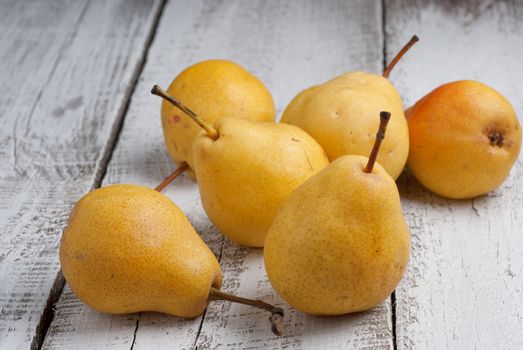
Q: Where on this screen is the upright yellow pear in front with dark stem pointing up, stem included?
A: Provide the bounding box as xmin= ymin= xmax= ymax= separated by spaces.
xmin=263 ymin=112 xmax=410 ymax=315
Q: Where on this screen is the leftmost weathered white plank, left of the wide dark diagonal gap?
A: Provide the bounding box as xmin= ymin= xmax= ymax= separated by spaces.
xmin=0 ymin=0 xmax=163 ymax=349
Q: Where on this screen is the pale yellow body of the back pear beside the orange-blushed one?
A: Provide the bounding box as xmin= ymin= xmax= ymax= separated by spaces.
xmin=281 ymin=72 xmax=409 ymax=179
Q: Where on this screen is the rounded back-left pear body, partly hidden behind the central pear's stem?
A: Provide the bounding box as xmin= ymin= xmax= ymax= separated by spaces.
xmin=162 ymin=60 xmax=276 ymax=178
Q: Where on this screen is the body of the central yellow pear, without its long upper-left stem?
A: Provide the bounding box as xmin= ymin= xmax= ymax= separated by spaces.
xmin=193 ymin=118 xmax=329 ymax=247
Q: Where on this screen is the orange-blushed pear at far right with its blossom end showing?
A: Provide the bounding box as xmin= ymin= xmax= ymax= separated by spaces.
xmin=412 ymin=80 xmax=521 ymax=199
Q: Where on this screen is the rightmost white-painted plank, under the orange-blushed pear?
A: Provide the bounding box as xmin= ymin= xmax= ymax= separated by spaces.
xmin=385 ymin=0 xmax=523 ymax=349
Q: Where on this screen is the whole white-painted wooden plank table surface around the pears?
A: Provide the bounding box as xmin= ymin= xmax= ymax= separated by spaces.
xmin=0 ymin=0 xmax=523 ymax=350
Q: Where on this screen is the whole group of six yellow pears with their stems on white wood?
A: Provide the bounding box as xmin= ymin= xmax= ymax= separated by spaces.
xmin=60 ymin=36 xmax=521 ymax=335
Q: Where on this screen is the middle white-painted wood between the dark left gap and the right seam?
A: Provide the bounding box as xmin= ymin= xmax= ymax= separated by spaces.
xmin=44 ymin=0 xmax=393 ymax=349
